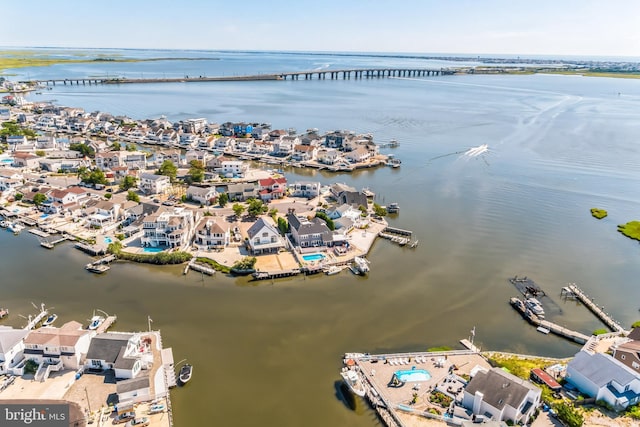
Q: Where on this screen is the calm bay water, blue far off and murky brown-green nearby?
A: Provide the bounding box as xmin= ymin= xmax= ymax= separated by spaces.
xmin=0 ymin=53 xmax=640 ymax=426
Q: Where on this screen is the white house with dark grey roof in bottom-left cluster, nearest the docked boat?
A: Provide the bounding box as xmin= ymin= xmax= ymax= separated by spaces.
xmin=85 ymin=332 xmax=144 ymax=379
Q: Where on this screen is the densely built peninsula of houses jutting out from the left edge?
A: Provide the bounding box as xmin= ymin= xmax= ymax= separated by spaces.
xmin=0 ymin=89 xmax=404 ymax=278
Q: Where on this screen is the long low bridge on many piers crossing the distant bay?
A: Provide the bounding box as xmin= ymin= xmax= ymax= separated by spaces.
xmin=25 ymin=68 xmax=456 ymax=86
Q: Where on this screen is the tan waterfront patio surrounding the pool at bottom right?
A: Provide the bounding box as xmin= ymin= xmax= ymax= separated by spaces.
xmin=344 ymin=350 xmax=491 ymax=426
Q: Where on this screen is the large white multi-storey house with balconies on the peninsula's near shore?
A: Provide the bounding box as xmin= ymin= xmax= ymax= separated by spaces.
xmin=140 ymin=208 xmax=194 ymax=248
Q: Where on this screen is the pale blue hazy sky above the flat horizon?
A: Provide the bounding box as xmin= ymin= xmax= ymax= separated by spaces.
xmin=5 ymin=0 xmax=640 ymax=57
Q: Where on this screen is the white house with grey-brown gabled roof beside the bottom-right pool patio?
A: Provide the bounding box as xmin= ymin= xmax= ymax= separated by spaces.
xmin=462 ymin=368 xmax=542 ymax=424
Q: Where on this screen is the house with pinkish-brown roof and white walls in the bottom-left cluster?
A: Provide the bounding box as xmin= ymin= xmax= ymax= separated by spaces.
xmin=24 ymin=321 xmax=93 ymax=370
